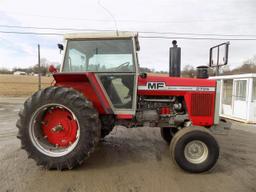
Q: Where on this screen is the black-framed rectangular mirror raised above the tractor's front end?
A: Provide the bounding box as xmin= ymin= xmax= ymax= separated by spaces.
xmin=209 ymin=42 xmax=230 ymax=67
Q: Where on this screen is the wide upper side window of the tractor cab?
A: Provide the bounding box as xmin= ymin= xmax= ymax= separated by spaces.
xmin=62 ymin=39 xmax=135 ymax=72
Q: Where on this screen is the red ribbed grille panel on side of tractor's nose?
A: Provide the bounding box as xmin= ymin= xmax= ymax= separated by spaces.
xmin=191 ymin=93 xmax=213 ymax=116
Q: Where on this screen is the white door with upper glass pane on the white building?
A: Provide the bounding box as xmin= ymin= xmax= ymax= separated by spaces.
xmin=232 ymin=79 xmax=248 ymax=119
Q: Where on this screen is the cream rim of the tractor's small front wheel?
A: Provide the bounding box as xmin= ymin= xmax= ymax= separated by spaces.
xmin=184 ymin=140 xmax=209 ymax=164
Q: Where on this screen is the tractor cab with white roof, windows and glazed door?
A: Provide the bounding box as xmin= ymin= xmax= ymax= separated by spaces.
xmin=61 ymin=32 xmax=139 ymax=114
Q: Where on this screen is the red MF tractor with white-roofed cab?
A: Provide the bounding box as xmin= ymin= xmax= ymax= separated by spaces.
xmin=17 ymin=32 xmax=229 ymax=173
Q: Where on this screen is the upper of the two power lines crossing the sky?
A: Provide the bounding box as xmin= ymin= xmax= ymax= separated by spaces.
xmin=0 ymin=25 xmax=256 ymax=37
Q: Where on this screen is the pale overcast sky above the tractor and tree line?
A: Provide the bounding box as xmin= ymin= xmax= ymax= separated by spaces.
xmin=0 ymin=0 xmax=256 ymax=71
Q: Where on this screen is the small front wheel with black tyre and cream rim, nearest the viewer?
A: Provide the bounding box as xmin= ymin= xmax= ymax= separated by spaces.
xmin=170 ymin=127 xmax=219 ymax=173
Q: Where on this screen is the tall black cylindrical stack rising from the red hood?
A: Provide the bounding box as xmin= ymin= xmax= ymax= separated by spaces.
xmin=169 ymin=40 xmax=181 ymax=77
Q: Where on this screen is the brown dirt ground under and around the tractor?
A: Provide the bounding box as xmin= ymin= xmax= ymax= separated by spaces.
xmin=0 ymin=98 xmax=256 ymax=192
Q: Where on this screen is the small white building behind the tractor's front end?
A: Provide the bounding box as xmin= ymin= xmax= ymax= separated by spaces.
xmin=209 ymin=73 xmax=256 ymax=123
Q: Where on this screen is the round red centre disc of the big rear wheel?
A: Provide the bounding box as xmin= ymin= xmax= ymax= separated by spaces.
xmin=42 ymin=108 xmax=78 ymax=147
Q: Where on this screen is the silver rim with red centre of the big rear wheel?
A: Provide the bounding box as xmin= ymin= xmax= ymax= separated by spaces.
xmin=29 ymin=103 xmax=80 ymax=157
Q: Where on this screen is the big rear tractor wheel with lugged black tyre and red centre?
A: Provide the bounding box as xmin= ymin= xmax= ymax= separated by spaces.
xmin=16 ymin=87 xmax=100 ymax=170
